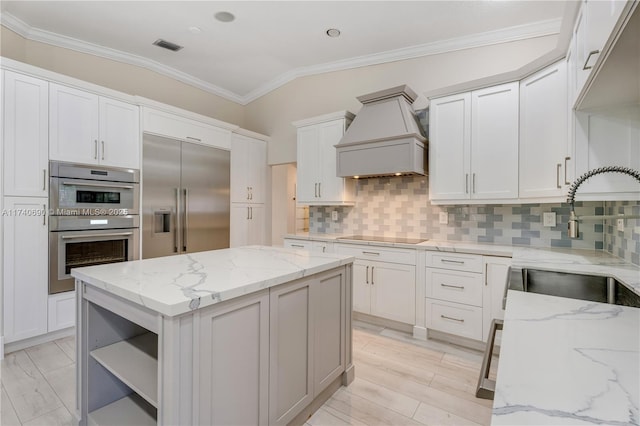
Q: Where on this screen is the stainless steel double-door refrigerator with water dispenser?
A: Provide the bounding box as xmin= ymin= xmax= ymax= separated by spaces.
xmin=142 ymin=134 xmax=230 ymax=259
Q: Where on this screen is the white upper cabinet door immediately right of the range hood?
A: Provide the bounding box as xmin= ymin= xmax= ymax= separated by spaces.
xmin=429 ymin=93 xmax=471 ymax=200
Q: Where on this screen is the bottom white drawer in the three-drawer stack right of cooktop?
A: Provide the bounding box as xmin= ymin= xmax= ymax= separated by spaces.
xmin=426 ymin=299 xmax=482 ymax=340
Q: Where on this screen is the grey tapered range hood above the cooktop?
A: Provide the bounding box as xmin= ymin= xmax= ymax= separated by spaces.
xmin=335 ymin=85 xmax=427 ymax=178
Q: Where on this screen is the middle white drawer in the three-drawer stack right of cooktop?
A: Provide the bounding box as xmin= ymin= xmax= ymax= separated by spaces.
xmin=426 ymin=268 xmax=482 ymax=307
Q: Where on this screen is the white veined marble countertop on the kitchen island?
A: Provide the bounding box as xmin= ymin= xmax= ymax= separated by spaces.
xmin=71 ymin=246 xmax=354 ymax=316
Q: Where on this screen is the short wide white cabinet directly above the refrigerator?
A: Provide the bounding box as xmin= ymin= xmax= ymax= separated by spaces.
xmin=142 ymin=107 xmax=231 ymax=150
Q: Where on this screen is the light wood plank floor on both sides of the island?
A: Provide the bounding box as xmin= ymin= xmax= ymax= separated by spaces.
xmin=0 ymin=322 xmax=496 ymax=426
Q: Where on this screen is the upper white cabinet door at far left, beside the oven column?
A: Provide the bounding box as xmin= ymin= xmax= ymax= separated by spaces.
xmin=3 ymin=71 xmax=49 ymax=197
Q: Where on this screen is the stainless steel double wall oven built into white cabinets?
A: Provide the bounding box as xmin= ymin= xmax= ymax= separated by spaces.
xmin=49 ymin=162 xmax=140 ymax=294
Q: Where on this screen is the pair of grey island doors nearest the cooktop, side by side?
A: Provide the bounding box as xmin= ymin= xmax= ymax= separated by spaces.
xmin=269 ymin=271 xmax=347 ymax=424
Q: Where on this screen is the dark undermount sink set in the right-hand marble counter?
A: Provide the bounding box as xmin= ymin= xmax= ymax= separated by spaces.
xmin=509 ymin=268 xmax=640 ymax=308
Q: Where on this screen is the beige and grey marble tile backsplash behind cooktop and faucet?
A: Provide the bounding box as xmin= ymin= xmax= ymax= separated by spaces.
xmin=309 ymin=176 xmax=640 ymax=264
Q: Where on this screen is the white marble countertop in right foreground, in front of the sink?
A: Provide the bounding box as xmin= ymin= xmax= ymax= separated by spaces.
xmin=491 ymin=290 xmax=640 ymax=425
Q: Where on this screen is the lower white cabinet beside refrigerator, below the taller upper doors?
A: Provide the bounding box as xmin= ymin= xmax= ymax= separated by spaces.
xmin=229 ymin=203 xmax=266 ymax=247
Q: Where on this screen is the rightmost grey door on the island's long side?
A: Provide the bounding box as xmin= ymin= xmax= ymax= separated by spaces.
xmin=311 ymin=268 xmax=346 ymax=396
